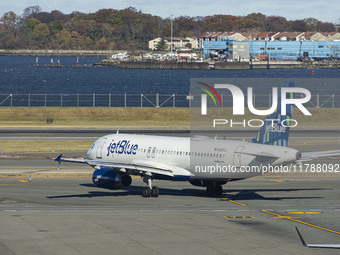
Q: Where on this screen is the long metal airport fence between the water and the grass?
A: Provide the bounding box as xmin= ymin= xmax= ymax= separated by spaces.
xmin=0 ymin=93 xmax=340 ymax=108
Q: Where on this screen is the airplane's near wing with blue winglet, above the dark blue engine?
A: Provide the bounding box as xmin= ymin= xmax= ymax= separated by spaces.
xmin=55 ymin=155 xmax=189 ymax=177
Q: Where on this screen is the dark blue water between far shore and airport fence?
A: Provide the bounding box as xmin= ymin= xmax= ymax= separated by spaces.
xmin=0 ymin=56 xmax=340 ymax=95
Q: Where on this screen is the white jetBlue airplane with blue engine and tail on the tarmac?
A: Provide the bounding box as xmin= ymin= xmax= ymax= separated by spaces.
xmin=55 ymin=90 xmax=340 ymax=197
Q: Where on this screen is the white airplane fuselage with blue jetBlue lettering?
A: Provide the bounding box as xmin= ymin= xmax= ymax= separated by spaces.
xmin=87 ymin=134 xmax=299 ymax=180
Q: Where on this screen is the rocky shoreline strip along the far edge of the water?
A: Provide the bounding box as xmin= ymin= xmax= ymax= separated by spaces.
xmin=0 ymin=49 xmax=340 ymax=70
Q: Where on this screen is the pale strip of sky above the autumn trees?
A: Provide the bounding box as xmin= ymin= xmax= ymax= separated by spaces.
xmin=0 ymin=0 xmax=340 ymax=23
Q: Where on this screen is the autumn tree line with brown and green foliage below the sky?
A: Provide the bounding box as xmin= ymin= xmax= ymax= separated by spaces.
xmin=0 ymin=6 xmax=336 ymax=50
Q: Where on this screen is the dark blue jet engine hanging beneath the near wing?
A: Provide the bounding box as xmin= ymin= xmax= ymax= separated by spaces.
xmin=92 ymin=168 xmax=132 ymax=189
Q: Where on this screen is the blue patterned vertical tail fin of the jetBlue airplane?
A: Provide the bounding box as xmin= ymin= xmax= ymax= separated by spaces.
xmin=251 ymin=82 xmax=296 ymax=147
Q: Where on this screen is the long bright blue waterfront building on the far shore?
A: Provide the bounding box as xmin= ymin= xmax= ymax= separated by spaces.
xmin=198 ymin=32 xmax=340 ymax=61
